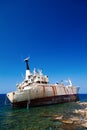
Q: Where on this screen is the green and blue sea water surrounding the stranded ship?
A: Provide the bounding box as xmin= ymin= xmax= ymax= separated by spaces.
xmin=0 ymin=94 xmax=87 ymax=130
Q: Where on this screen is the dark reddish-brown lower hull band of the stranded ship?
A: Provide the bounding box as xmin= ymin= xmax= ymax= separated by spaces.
xmin=12 ymin=94 xmax=79 ymax=108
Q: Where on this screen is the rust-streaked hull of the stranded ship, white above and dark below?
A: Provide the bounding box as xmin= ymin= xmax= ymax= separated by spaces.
xmin=7 ymin=83 xmax=79 ymax=107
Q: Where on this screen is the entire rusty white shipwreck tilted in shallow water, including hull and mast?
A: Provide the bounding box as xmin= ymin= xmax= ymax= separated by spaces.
xmin=7 ymin=58 xmax=79 ymax=107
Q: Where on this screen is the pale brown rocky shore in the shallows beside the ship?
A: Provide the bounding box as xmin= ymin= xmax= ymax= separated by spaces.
xmin=42 ymin=102 xmax=87 ymax=130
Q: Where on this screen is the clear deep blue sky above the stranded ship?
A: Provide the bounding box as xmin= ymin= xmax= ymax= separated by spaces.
xmin=0 ymin=0 xmax=87 ymax=93
